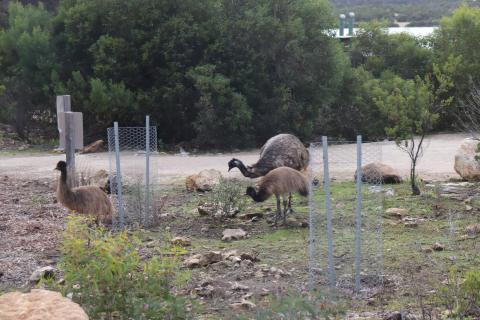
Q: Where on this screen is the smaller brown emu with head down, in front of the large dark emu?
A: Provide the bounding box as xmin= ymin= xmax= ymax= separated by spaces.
xmin=246 ymin=167 xmax=309 ymax=225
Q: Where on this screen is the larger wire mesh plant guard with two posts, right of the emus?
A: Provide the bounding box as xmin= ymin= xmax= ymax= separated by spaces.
xmin=309 ymin=137 xmax=385 ymax=293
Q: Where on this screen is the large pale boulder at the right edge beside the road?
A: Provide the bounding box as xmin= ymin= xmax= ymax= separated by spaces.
xmin=453 ymin=138 xmax=480 ymax=181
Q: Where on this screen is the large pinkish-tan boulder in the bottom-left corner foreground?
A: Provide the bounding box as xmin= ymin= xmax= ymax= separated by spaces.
xmin=0 ymin=290 xmax=88 ymax=320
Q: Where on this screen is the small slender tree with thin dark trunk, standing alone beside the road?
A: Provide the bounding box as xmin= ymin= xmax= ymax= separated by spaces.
xmin=375 ymin=66 xmax=453 ymax=195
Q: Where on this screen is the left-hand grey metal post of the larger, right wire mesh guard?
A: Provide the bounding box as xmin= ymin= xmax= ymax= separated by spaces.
xmin=322 ymin=136 xmax=337 ymax=287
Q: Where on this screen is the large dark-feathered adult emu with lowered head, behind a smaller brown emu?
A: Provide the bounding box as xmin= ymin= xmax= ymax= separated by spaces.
xmin=228 ymin=133 xmax=310 ymax=210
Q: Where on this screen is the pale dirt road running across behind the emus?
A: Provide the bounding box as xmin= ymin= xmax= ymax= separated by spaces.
xmin=0 ymin=134 xmax=467 ymax=183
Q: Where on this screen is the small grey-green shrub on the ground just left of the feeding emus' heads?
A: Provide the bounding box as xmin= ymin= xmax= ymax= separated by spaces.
xmin=207 ymin=177 xmax=247 ymax=216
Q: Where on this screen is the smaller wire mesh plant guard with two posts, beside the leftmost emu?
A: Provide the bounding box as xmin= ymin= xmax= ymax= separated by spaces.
xmin=107 ymin=117 xmax=161 ymax=228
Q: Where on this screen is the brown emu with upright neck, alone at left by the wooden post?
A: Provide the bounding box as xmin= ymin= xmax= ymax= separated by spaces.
xmin=55 ymin=161 xmax=113 ymax=223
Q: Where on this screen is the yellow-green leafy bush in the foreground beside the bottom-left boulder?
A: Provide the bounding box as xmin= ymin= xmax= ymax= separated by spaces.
xmin=54 ymin=216 xmax=188 ymax=320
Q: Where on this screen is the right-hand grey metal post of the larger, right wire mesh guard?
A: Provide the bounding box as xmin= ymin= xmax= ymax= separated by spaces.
xmin=355 ymin=136 xmax=362 ymax=292
